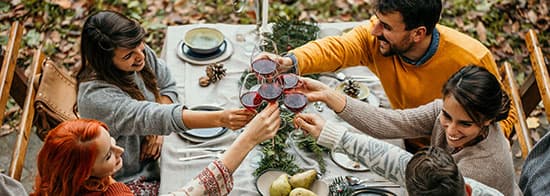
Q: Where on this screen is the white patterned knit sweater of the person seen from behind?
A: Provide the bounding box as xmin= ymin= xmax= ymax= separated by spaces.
xmin=317 ymin=121 xmax=503 ymax=196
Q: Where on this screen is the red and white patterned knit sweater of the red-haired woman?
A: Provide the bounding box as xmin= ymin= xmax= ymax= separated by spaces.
xmin=79 ymin=160 xmax=233 ymax=196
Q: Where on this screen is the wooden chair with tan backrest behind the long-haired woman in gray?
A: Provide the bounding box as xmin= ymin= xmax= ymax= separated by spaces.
xmin=0 ymin=22 xmax=77 ymax=180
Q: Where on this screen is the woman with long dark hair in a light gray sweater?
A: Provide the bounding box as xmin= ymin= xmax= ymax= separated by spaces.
xmin=77 ymin=11 xmax=254 ymax=191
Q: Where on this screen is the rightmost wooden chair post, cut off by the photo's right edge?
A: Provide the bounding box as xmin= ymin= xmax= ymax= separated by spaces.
xmin=525 ymin=29 xmax=550 ymax=121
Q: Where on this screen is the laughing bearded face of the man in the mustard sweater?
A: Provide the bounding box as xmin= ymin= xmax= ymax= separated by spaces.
xmin=371 ymin=12 xmax=414 ymax=56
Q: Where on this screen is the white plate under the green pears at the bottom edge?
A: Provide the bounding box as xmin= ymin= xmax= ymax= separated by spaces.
xmin=256 ymin=170 xmax=329 ymax=196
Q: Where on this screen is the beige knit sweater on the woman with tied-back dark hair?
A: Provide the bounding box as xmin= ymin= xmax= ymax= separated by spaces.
xmin=338 ymin=97 xmax=521 ymax=195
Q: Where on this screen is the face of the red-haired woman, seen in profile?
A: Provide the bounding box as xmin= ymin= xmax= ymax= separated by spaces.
xmin=92 ymin=128 xmax=124 ymax=178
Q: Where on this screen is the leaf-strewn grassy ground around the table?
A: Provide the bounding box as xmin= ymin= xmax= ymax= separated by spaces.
xmin=0 ymin=0 xmax=550 ymax=191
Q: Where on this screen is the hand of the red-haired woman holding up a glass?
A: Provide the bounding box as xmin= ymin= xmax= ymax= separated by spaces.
xmin=241 ymin=103 xmax=281 ymax=146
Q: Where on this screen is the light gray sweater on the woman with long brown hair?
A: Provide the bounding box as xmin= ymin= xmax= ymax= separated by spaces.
xmin=77 ymin=47 xmax=187 ymax=182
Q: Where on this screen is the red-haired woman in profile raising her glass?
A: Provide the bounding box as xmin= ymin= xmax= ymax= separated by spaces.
xmin=31 ymin=104 xmax=280 ymax=196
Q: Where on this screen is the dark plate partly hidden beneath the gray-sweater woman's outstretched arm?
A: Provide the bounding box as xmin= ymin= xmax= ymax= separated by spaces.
xmin=178 ymin=105 xmax=227 ymax=143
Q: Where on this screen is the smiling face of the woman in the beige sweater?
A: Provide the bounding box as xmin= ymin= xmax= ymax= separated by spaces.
xmin=439 ymin=95 xmax=490 ymax=148
